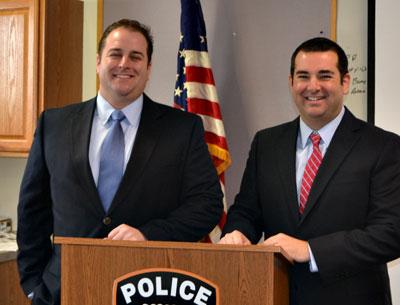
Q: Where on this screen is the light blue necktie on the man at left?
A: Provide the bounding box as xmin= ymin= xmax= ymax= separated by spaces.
xmin=97 ymin=110 xmax=125 ymax=212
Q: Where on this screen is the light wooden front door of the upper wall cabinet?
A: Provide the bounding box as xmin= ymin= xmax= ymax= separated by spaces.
xmin=0 ymin=0 xmax=39 ymax=156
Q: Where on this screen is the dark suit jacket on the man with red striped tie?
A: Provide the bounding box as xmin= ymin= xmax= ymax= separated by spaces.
xmin=224 ymin=109 xmax=400 ymax=305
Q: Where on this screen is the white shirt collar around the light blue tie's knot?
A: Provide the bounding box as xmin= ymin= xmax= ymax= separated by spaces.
xmin=96 ymin=92 xmax=143 ymax=127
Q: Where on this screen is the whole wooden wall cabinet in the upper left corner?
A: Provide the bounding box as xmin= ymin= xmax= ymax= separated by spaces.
xmin=0 ymin=0 xmax=83 ymax=156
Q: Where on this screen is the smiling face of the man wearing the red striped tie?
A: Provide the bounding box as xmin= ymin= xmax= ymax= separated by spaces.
xmin=289 ymin=51 xmax=350 ymax=129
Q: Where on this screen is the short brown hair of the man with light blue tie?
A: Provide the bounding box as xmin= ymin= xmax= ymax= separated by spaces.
xmin=97 ymin=19 xmax=153 ymax=63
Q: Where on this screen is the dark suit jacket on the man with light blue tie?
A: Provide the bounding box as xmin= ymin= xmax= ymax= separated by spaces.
xmin=17 ymin=96 xmax=223 ymax=305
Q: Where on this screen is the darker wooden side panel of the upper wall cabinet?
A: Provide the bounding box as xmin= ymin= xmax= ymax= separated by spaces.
xmin=39 ymin=0 xmax=83 ymax=113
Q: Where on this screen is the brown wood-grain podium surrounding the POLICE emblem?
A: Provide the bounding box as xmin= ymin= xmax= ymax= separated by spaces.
xmin=55 ymin=237 xmax=289 ymax=305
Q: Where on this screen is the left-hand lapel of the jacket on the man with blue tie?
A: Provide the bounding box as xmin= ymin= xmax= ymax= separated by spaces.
xmin=68 ymin=98 xmax=104 ymax=215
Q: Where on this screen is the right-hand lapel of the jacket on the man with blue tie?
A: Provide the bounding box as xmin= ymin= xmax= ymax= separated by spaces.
xmin=110 ymin=95 xmax=162 ymax=212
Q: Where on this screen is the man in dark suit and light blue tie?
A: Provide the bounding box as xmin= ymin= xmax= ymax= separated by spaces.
xmin=17 ymin=19 xmax=222 ymax=305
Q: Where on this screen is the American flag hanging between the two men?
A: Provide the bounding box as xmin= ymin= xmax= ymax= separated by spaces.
xmin=174 ymin=0 xmax=231 ymax=242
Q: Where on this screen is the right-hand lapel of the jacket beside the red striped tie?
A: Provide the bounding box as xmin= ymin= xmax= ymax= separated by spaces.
xmin=300 ymin=109 xmax=361 ymax=223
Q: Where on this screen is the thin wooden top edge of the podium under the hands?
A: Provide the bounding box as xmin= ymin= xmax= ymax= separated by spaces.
xmin=54 ymin=236 xmax=290 ymax=261
